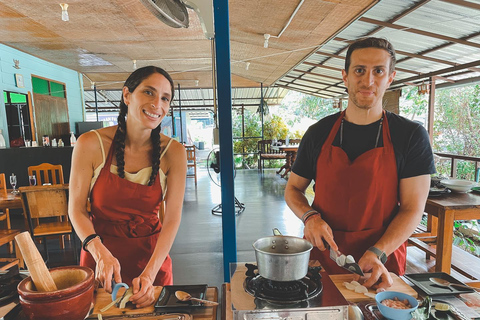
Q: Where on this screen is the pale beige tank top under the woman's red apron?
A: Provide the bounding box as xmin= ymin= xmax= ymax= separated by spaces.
xmin=90 ymin=130 xmax=173 ymax=196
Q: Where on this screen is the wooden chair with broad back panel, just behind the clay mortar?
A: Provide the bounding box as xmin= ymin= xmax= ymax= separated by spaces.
xmin=19 ymin=184 xmax=78 ymax=263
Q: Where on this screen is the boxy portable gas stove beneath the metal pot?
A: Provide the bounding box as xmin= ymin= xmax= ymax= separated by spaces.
xmin=226 ymin=263 xmax=356 ymax=320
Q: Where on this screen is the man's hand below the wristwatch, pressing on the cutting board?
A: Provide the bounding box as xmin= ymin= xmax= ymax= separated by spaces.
xmin=355 ymin=251 xmax=393 ymax=289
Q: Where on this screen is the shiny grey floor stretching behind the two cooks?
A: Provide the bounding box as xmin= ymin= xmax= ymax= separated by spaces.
xmin=0 ymin=168 xmax=468 ymax=288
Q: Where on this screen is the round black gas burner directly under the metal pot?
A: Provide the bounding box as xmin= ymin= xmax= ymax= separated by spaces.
xmin=243 ymin=263 xmax=323 ymax=307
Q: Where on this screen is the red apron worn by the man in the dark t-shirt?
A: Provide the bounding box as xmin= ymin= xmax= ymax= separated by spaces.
xmin=310 ymin=111 xmax=407 ymax=275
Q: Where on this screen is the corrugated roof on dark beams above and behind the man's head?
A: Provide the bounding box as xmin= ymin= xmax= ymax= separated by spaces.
xmin=276 ymin=0 xmax=480 ymax=98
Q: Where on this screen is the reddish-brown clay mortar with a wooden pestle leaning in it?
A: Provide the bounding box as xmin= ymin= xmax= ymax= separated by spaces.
xmin=18 ymin=266 xmax=94 ymax=320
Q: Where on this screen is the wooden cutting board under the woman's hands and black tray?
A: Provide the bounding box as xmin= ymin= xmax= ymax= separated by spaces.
xmin=88 ymin=287 xmax=218 ymax=320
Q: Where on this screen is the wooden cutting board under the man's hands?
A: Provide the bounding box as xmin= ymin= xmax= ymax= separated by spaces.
xmin=330 ymin=272 xmax=418 ymax=302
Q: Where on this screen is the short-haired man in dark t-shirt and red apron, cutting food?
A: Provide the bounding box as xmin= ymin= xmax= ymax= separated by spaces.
xmin=285 ymin=38 xmax=435 ymax=288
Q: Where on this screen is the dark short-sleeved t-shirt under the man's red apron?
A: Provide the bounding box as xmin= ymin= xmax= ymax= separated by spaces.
xmin=292 ymin=111 xmax=436 ymax=180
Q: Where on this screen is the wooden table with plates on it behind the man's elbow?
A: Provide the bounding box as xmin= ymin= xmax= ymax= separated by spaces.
xmin=425 ymin=192 xmax=480 ymax=273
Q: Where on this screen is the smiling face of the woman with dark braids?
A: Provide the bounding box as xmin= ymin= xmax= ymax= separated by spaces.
xmin=123 ymin=73 xmax=172 ymax=129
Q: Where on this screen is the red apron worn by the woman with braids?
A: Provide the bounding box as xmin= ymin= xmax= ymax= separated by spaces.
xmin=80 ymin=143 xmax=173 ymax=286
